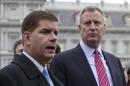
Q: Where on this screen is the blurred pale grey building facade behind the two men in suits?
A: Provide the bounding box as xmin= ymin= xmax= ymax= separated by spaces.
xmin=0 ymin=0 xmax=130 ymax=68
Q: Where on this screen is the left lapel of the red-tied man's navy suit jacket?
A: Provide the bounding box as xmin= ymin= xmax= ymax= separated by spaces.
xmin=73 ymin=45 xmax=97 ymax=86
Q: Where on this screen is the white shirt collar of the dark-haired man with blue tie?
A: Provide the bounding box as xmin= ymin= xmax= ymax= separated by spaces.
xmin=22 ymin=51 xmax=47 ymax=73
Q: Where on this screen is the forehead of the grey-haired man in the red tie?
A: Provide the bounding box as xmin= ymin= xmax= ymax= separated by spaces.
xmin=81 ymin=11 xmax=103 ymax=20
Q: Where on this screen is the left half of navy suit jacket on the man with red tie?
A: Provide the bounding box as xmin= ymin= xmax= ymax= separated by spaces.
xmin=51 ymin=45 xmax=97 ymax=86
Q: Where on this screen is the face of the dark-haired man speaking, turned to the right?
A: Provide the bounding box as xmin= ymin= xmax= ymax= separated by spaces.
xmin=24 ymin=20 xmax=58 ymax=64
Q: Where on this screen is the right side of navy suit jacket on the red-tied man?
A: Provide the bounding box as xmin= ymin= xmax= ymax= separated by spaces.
xmin=103 ymin=51 xmax=126 ymax=86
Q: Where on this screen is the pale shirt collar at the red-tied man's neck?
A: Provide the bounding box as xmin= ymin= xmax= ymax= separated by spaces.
xmin=80 ymin=40 xmax=102 ymax=57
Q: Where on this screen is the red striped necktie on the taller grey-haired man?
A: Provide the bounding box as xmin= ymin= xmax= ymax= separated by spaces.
xmin=94 ymin=50 xmax=110 ymax=86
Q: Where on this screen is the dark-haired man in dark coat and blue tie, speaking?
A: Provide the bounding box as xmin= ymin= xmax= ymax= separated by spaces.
xmin=0 ymin=11 xmax=62 ymax=86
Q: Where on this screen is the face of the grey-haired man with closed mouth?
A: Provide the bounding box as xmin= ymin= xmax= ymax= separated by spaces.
xmin=79 ymin=11 xmax=105 ymax=48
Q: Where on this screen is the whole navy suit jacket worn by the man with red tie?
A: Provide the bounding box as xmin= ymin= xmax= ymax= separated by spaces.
xmin=51 ymin=45 xmax=126 ymax=86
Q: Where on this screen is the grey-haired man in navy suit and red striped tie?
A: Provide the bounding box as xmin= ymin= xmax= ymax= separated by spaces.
xmin=51 ymin=6 xmax=126 ymax=86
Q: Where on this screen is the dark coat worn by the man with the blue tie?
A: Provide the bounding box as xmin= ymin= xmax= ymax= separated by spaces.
xmin=0 ymin=54 xmax=63 ymax=86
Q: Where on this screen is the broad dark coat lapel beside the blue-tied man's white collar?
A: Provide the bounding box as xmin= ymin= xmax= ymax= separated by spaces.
xmin=12 ymin=54 xmax=49 ymax=86
